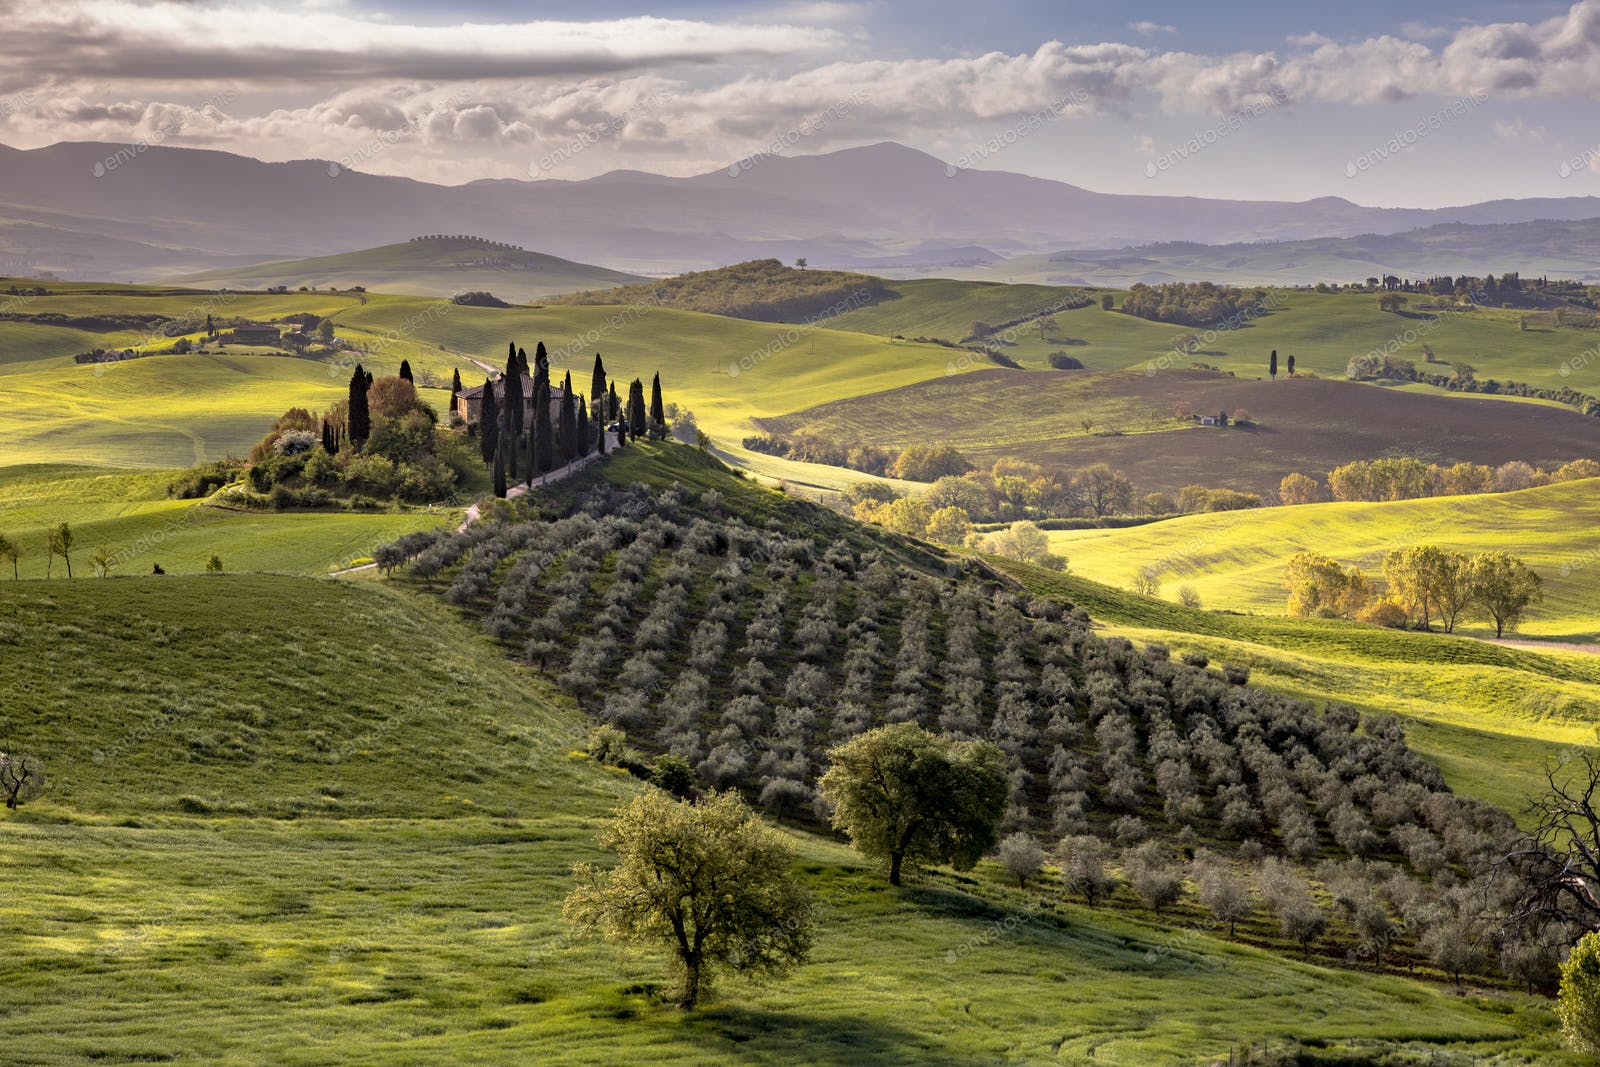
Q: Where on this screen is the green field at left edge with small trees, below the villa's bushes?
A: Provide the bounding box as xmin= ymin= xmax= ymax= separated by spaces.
xmin=0 ymin=466 xmax=459 ymax=581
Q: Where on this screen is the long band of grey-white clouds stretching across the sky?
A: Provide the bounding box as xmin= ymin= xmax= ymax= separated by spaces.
xmin=9 ymin=0 xmax=1600 ymax=181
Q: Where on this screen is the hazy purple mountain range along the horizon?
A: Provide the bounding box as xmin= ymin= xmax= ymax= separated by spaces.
xmin=0 ymin=142 xmax=1600 ymax=280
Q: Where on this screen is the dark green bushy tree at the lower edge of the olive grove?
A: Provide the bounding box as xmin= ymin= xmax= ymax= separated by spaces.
xmin=818 ymin=723 xmax=1010 ymax=886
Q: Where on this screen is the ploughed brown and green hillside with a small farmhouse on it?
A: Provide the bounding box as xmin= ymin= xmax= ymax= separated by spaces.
xmin=760 ymin=370 xmax=1600 ymax=494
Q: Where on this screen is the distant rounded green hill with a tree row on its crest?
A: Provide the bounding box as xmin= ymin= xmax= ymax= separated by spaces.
xmin=174 ymin=237 xmax=643 ymax=304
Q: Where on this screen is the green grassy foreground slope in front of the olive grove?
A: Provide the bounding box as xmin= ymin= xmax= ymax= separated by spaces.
xmin=0 ymin=576 xmax=1568 ymax=1064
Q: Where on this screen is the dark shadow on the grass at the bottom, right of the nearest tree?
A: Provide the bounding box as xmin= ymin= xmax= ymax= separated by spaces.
xmin=694 ymin=1006 xmax=960 ymax=1067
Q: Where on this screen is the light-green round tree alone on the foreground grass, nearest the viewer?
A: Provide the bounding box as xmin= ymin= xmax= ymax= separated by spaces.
xmin=563 ymin=790 xmax=813 ymax=1009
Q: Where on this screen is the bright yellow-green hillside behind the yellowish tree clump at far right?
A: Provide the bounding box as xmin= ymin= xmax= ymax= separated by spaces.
xmin=1050 ymin=482 xmax=1600 ymax=641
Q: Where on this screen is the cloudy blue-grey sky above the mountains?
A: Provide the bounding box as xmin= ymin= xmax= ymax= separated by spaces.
xmin=0 ymin=0 xmax=1600 ymax=206
